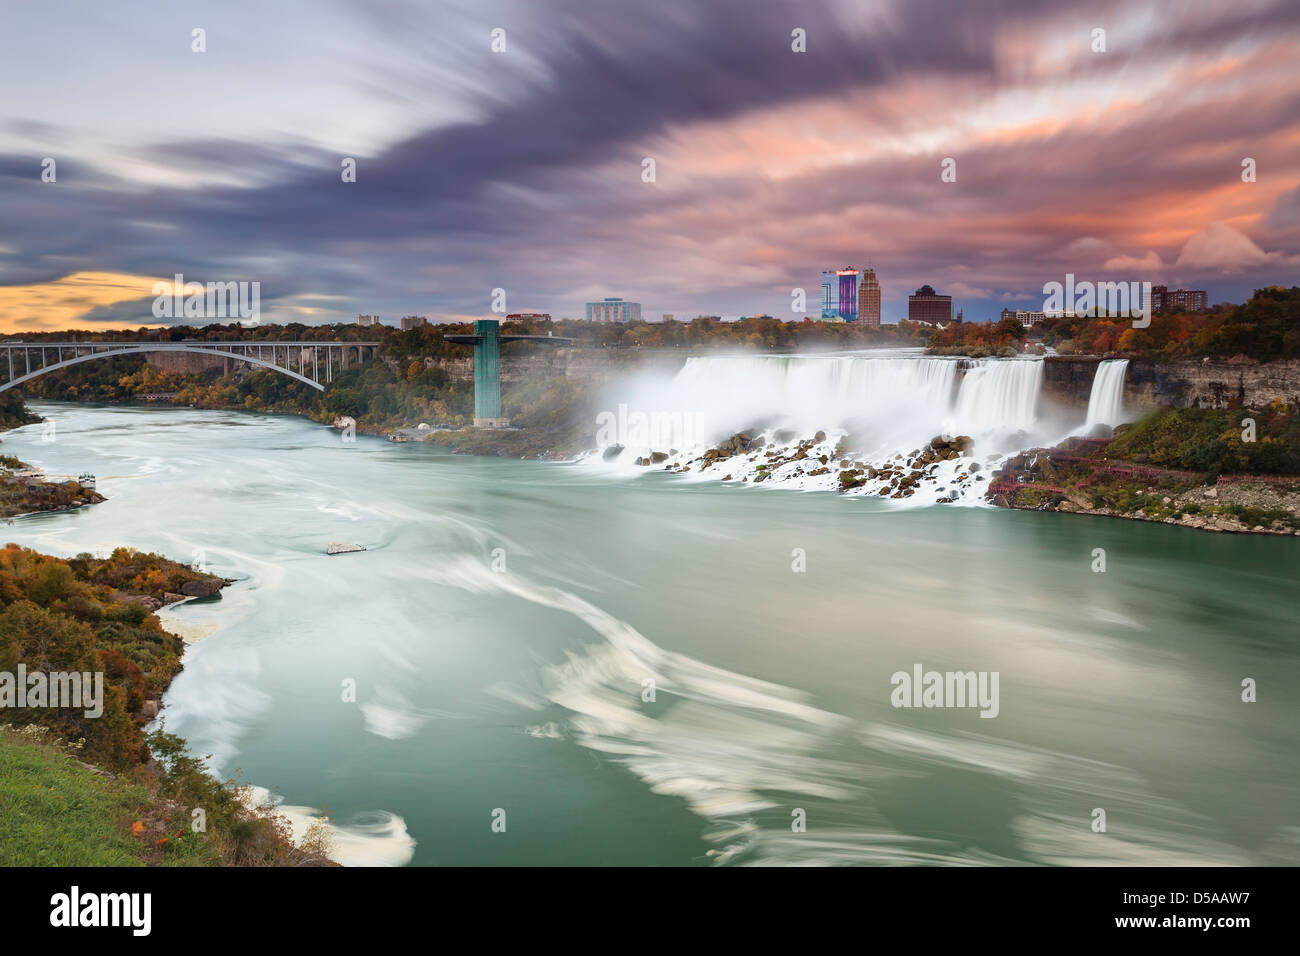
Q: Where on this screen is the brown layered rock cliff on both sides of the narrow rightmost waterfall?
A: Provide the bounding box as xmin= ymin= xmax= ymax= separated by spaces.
xmin=1043 ymin=355 xmax=1300 ymax=408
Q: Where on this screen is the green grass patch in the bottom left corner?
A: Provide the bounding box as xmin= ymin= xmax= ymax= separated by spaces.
xmin=0 ymin=731 xmax=150 ymax=866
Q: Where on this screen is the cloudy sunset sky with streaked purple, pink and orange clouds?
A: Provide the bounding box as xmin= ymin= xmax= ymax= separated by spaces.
xmin=0 ymin=0 xmax=1300 ymax=334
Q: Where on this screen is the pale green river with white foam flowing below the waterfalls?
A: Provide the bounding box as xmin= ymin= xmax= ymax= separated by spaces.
xmin=3 ymin=403 xmax=1300 ymax=865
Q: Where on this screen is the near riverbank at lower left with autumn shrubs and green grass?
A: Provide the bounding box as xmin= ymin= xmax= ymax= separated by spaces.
xmin=0 ymin=545 xmax=330 ymax=866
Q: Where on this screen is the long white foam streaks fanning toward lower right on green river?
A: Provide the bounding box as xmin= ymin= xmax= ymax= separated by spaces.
xmin=429 ymin=557 xmax=1268 ymax=866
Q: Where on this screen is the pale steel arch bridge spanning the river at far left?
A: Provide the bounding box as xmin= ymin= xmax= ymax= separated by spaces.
xmin=0 ymin=339 xmax=380 ymax=392
